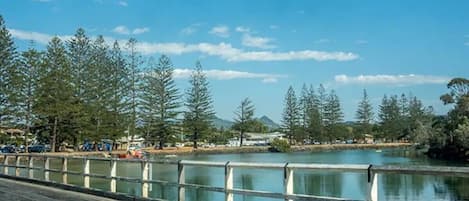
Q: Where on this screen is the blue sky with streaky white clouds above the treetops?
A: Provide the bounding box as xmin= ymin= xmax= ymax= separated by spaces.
xmin=0 ymin=0 xmax=469 ymax=122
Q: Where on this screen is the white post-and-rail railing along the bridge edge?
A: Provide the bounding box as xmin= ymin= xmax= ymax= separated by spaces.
xmin=0 ymin=154 xmax=469 ymax=201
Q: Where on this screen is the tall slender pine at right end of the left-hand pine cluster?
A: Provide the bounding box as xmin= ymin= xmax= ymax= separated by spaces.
xmin=184 ymin=62 xmax=215 ymax=148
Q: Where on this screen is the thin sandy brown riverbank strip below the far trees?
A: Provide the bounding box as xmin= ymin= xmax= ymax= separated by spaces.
xmin=3 ymin=143 xmax=412 ymax=157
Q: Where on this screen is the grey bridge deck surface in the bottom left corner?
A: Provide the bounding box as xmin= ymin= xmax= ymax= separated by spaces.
xmin=0 ymin=178 xmax=113 ymax=201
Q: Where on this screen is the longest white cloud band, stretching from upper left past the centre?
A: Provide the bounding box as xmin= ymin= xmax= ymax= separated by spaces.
xmin=9 ymin=29 xmax=359 ymax=62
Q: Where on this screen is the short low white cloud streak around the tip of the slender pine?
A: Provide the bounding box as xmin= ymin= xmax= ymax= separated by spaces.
xmin=173 ymin=68 xmax=286 ymax=83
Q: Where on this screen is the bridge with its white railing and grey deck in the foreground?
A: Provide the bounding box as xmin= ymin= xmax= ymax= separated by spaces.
xmin=0 ymin=154 xmax=469 ymax=201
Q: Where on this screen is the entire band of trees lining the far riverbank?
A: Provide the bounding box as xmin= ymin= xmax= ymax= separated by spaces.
xmin=0 ymin=16 xmax=469 ymax=160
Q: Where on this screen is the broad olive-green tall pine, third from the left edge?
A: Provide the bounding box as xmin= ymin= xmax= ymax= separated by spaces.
xmin=34 ymin=37 xmax=76 ymax=151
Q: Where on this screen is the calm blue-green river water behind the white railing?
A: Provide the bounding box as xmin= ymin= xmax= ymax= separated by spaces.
xmin=16 ymin=149 xmax=469 ymax=201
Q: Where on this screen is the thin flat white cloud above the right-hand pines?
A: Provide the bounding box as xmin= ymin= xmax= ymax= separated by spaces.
xmin=334 ymin=74 xmax=451 ymax=86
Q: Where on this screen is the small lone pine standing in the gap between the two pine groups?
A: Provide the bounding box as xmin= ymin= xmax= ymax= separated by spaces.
xmin=233 ymin=98 xmax=254 ymax=146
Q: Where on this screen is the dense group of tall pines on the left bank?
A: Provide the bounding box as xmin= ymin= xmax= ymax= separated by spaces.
xmin=0 ymin=16 xmax=214 ymax=150
